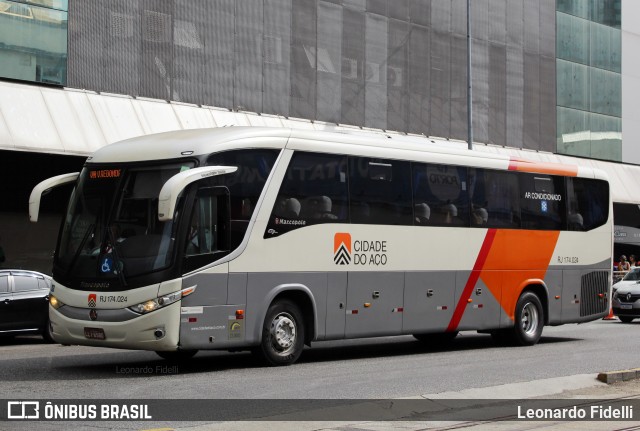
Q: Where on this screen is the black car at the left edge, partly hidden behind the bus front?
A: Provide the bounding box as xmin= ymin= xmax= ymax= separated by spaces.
xmin=0 ymin=269 xmax=52 ymax=341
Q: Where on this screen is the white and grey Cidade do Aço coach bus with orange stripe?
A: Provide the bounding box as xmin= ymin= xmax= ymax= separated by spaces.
xmin=29 ymin=127 xmax=613 ymax=365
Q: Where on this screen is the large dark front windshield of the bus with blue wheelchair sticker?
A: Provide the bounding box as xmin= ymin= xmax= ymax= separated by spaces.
xmin=54 ymin=162 xmax=195 ymax=287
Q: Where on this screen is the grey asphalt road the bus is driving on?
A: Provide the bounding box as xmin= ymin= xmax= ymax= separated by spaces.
xmin=0 ymin=320 xmax=640 ymax=399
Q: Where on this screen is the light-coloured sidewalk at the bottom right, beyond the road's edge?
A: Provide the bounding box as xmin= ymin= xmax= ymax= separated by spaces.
xmin=176 ymin=370 xmax=640 ymax=431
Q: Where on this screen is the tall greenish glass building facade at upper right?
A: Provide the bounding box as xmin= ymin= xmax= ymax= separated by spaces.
xmin=556 ymin=0 xmax=622 ymax=161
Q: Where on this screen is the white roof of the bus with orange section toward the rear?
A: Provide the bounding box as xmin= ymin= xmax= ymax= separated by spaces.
xmin=87 ymin=127 xmax=606 ymax=178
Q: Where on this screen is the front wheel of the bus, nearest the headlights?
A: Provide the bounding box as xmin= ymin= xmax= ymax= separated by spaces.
xmin=256 ymin=300 xmax=305 ymax=366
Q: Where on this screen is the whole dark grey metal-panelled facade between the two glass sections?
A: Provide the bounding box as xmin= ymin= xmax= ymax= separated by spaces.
xmin=63 ymin=0 xmax=556 ymax=154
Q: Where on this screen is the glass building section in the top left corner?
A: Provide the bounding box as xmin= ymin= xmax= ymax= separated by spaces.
xmin=0 ymin=0 xmax=68 ymax=85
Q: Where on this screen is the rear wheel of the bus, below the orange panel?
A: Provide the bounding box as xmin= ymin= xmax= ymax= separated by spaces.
xmin=509 ymin=292 xmax=544 ymax=346
